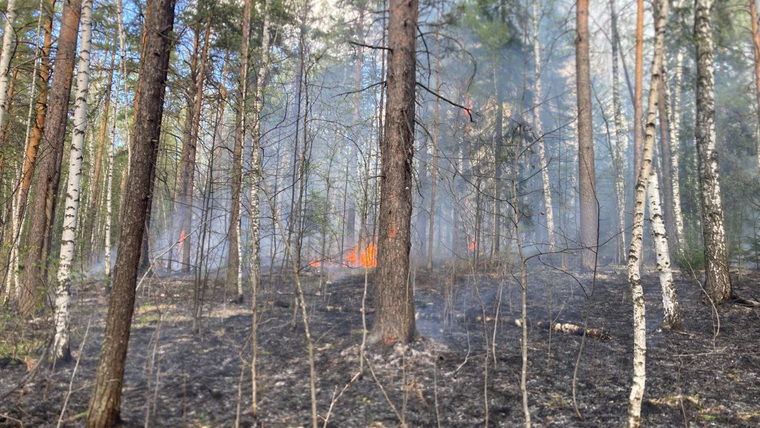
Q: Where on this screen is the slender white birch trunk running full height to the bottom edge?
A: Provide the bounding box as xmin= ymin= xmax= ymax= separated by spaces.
xmin=628 ymin=0 xmax=668 ymax=428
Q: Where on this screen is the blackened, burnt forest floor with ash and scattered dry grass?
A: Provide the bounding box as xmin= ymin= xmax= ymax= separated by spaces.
xmin=0 ymin=267 xmax=760 ymax=427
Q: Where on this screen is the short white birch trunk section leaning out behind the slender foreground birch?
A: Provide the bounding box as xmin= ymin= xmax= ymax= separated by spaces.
xmin=647 ymin=169 xmax=681 ymax=330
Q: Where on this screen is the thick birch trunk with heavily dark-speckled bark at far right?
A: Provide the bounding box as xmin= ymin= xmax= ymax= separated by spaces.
xmin=694 ymin=0 xmax=732 ymax=303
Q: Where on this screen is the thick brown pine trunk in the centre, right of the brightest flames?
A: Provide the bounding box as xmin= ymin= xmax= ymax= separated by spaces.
xmin=371 ymin=0 xmax=418 ymax=344
